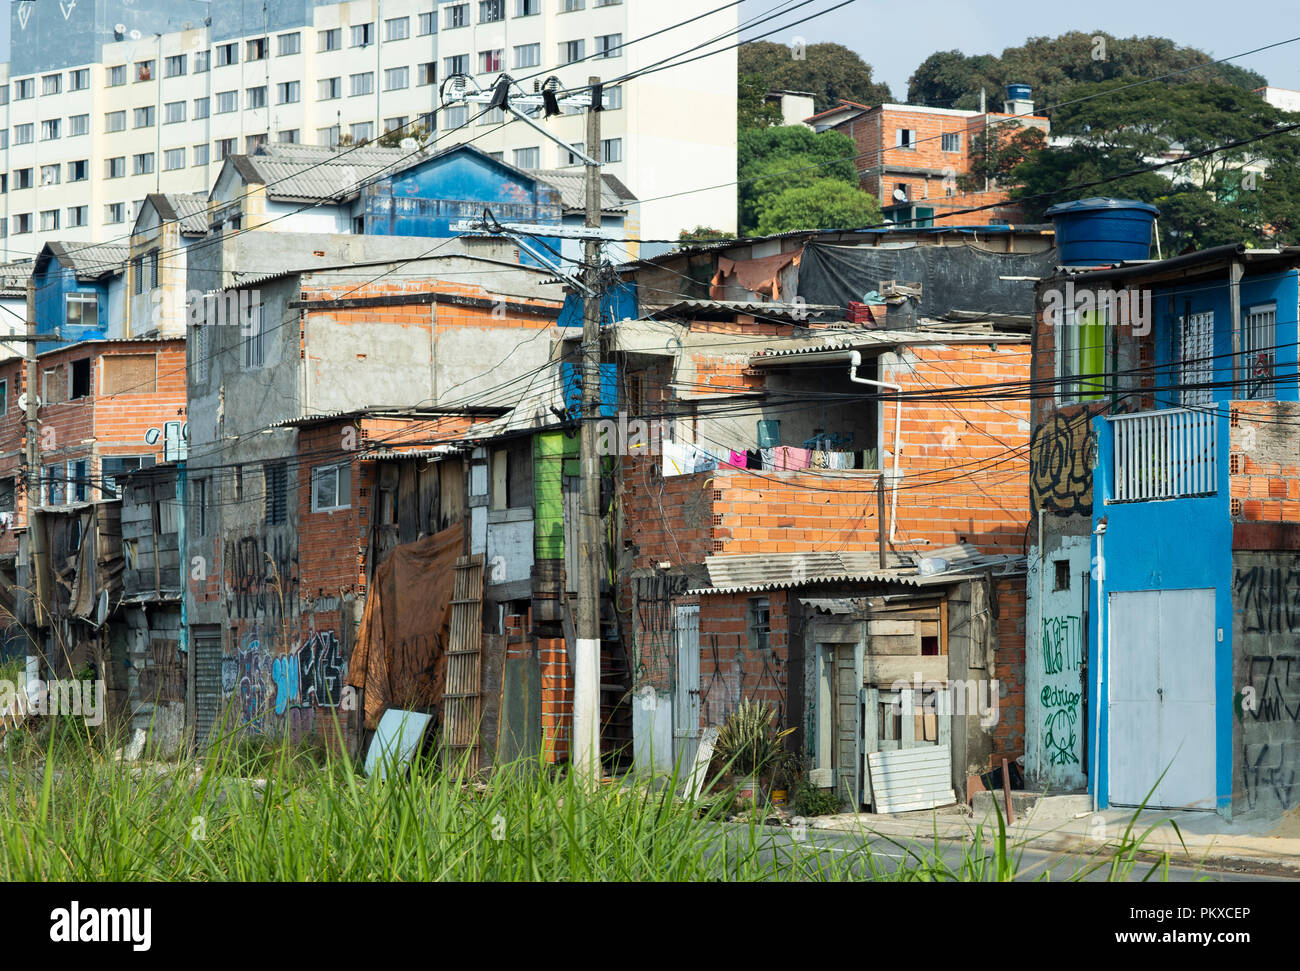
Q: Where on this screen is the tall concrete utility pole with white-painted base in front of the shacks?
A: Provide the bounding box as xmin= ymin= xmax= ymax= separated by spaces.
xmin=572 ymin=77 xmax=603 ymax=780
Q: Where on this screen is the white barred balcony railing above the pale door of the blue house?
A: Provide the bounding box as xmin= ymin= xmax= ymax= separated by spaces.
xmin=1109 ymin=408 xmax=1218 ymax=502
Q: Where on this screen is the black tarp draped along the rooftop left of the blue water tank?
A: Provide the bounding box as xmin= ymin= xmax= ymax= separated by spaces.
xmin=798 ymin=243 xmax=1057 ymax=317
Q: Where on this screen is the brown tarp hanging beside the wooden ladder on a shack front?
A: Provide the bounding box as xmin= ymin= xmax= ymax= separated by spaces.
xmin=347 ymin=523 xmax=464 ymax=729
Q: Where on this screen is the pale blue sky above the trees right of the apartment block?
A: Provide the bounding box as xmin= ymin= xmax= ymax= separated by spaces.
xmin=738 ymin=0 xmax=1300 ymax=101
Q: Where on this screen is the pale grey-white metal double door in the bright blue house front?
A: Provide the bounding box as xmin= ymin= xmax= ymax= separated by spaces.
xmin=1108 ymin=590 xmax=1216 ymax=810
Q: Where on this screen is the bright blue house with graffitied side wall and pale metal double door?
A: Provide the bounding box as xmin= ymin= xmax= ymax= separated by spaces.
xmin=1026 ymin=222 xmax=1300 ymax=818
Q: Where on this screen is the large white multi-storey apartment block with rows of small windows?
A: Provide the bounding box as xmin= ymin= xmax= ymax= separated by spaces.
xmin=0 ymin=0 xmax=737 ymax=260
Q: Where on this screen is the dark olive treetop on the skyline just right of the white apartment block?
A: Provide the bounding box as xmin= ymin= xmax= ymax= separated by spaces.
xmin=737 ymin=40 xmax=893 ymax=112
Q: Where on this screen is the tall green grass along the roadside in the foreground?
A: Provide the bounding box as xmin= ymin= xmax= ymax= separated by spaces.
xmin=0 ymin=719 xmax=1190 ymax=881
